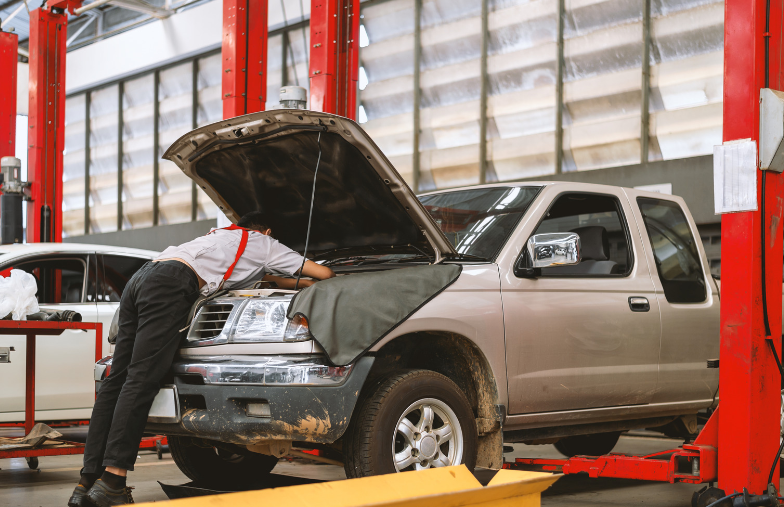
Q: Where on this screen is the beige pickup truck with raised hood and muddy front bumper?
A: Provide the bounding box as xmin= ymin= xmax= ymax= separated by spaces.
xmin=96 ymin=110 xmax=719 ymax=481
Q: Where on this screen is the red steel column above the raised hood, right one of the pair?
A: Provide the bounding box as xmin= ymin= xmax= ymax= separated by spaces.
xmin=310 ymin=0 xmax=359 ymax=120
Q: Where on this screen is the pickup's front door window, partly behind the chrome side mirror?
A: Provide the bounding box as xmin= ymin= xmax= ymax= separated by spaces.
xmin=525 ymin=194 xmax=632 ymax=276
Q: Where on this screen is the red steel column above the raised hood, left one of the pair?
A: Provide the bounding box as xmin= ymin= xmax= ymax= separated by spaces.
xmin=221 ymin=0 xmax=267 ymax=118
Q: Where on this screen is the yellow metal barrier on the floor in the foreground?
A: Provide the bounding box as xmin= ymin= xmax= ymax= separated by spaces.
xmin=141 ymin=465 xmax=560 ymax=507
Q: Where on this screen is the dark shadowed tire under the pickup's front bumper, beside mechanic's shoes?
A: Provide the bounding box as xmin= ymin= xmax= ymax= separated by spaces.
xmin=167 ymin=436 xmax=278 ymax=486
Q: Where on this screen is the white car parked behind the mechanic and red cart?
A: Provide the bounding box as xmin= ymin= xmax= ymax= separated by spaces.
xmin=0 ymin=243 xmax=157 ymax=423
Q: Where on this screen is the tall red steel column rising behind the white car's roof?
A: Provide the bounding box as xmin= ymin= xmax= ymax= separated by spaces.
xmin=27 ymin=9 xmax=68 ymax=243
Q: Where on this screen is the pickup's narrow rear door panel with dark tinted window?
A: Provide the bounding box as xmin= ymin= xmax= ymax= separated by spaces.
xmin=629 ymin=191 xmax=720 ymax=407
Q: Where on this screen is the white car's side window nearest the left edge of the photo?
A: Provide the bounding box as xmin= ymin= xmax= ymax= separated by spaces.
xmin=10 ymin=257 xmax=87 ymax=304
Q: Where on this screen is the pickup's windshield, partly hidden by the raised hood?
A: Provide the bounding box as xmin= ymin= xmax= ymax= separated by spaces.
xmin=419 ymin=186 xmax=542 ymax=260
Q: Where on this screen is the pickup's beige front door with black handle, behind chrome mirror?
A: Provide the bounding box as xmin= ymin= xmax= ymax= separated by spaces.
xmin=502 ymin=189 xmax=661 ymax=414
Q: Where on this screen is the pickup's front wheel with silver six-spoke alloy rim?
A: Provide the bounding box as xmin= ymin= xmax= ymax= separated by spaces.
xmin=343 ymin=370 xmax=478 ymax=478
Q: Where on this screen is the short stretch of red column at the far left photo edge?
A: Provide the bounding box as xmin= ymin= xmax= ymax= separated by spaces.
xmin=0 ymin=32 xmax=19 ymax=157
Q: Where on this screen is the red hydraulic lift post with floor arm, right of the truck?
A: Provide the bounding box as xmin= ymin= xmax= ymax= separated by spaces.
xmin=506 ymin=0 xmax=784 ymax=507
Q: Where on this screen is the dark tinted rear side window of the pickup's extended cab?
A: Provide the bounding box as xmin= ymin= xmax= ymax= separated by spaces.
xmin=637 ymin=197 xmax=707 ymax=303
